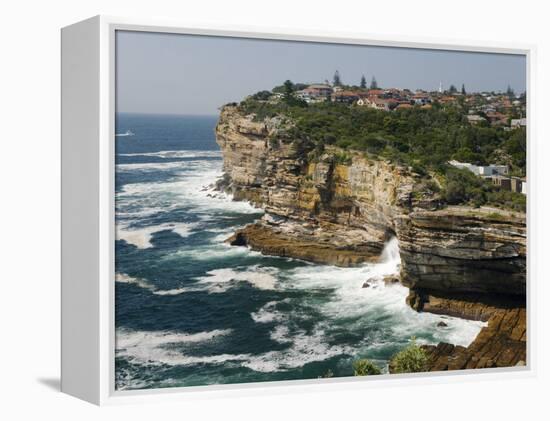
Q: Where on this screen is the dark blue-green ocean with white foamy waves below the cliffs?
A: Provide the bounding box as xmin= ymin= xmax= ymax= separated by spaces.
xmin=115 ymin=114 xmax=484 ymax=390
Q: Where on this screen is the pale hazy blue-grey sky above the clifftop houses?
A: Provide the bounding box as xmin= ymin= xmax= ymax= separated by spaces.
xmin=116 ymin=31 xmax=526 ymax=115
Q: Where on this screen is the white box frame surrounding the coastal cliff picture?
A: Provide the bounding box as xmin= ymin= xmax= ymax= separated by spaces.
xmin=61 ymin=16 xmax=536 ymax=405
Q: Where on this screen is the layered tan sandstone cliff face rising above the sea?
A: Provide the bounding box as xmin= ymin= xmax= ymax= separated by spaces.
xmin=216 ymin=106 xmax=526 ymax=300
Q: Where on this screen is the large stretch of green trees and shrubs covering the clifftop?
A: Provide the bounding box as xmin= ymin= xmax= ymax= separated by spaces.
xmin=238 ymin=81 xmax=527 ymax=211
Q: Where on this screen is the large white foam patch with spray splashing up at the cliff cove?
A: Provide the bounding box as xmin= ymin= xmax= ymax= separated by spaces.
xmin=280 ymin=236 xmax=485 ymax=346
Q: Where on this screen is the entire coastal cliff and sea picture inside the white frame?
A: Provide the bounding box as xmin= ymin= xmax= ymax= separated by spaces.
xmin=114 ymin=31 xmax=528 ymax=391
